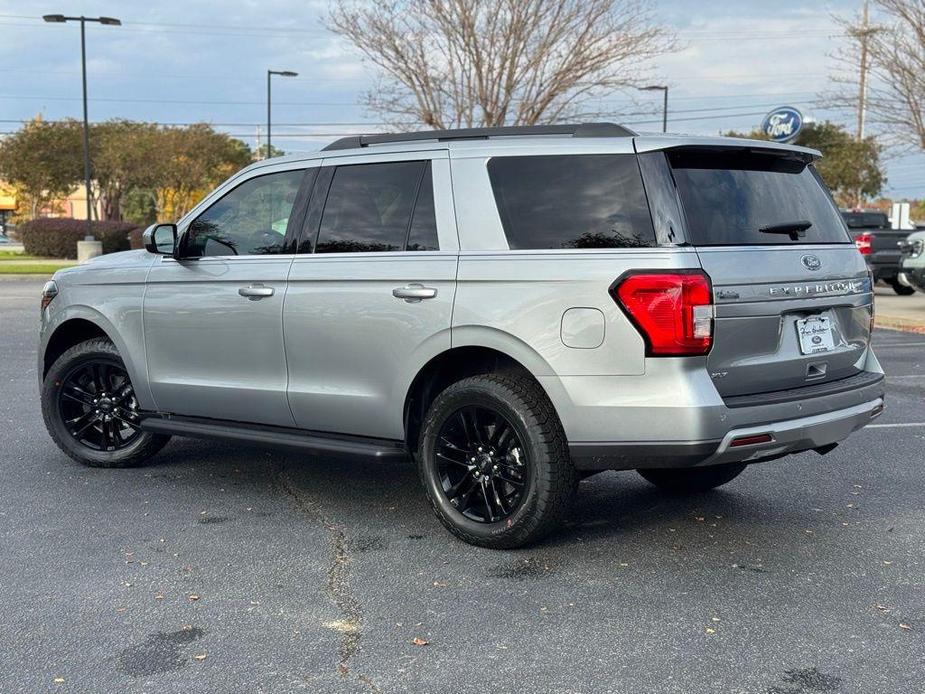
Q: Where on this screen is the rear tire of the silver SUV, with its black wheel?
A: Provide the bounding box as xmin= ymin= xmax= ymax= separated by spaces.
xmin=416 ymin=374 xmax=577 ymax=549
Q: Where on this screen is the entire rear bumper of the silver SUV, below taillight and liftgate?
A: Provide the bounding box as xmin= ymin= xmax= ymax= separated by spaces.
xmin=539 ymin=350 xmax=885 ymax=470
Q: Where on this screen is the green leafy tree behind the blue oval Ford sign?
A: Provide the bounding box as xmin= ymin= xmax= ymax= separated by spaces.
xmin=723 ymin=121 xmax=886 ymax=206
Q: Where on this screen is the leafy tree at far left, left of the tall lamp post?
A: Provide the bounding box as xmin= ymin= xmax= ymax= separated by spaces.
xmin=0 ymin=117 xmax=83 ymax=219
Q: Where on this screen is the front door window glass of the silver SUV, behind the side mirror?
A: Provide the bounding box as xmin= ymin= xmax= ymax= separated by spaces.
xmin=184 ymin=171 xmax=305 ymax=257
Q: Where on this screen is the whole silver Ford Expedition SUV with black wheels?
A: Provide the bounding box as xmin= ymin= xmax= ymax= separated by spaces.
xmin=39 ymin=124 xmax=883 ymax=547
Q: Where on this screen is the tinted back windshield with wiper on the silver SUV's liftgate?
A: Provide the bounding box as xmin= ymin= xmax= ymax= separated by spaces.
xmin=668 ymin=150 xmax=851 ymax=246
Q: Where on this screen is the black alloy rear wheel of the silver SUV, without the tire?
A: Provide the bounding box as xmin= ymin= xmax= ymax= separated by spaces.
xmin=434 ymin=405 xmax=530 ymax=523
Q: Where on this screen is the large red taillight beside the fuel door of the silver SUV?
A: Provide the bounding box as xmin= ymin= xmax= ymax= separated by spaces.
xmin=610 ymin=270 xmax=713 ymax=357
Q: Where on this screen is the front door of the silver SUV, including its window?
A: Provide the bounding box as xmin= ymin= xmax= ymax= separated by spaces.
xmin=144 ymin=168 xmax=317 ymax=426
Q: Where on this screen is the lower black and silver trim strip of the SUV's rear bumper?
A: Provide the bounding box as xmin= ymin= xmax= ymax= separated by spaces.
xmin=569 ymin=397 xmax=883 ymax=470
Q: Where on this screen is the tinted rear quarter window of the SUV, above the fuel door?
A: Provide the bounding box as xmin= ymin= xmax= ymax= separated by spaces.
xmin=488 ymin=154 xmax=655 ymax=249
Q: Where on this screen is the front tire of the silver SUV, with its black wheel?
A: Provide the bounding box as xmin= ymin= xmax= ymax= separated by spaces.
xmin=42 ymin=338 xmax=170 ymax=468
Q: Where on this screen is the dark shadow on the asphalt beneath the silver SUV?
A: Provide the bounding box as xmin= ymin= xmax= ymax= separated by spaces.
xmin=146 ymin=439 xmax=844 ymax=550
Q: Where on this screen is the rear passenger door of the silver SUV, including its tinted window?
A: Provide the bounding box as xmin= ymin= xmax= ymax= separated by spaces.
xmin=283 ymin=150 xmax=458 ymax=439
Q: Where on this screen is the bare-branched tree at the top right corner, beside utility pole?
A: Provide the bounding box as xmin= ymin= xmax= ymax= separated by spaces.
xmin=824 ymin=0 xmax=925 ymax=150
